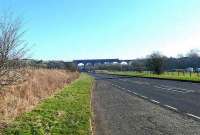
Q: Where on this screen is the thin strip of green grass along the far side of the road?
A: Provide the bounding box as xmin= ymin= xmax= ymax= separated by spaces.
xmin=103 ymin=71 xmax=200 ymax=82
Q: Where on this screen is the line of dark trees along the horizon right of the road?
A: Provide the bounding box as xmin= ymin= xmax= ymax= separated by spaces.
xmin=95 ymin=49 xmax=200 ymax=74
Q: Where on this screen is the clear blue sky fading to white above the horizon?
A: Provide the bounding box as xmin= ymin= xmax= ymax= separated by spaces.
xmin=0 ymin=0 xmax=200 ymax=60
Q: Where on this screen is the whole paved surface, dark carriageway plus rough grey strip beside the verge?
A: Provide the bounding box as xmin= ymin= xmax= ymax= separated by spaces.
xmin=91 ymin=74 xmax=200 ymax=135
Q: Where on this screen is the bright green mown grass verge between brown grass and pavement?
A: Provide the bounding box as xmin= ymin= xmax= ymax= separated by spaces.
xmin=4 ymin=74 xmax=93 ymax=135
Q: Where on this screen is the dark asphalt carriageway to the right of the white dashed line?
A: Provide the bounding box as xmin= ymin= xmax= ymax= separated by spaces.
xmin=94 ymin=74 xmax=200 ymax=119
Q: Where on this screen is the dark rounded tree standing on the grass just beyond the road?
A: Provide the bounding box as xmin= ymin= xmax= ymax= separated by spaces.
xmin=146 ymin=52 xmax=166 ymax=74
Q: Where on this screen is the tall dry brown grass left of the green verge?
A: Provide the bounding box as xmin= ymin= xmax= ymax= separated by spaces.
xmin=0 ymin=69 xmax=79 ymax=126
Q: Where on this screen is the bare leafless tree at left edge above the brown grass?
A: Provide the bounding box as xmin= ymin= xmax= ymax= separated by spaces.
xmin=0 ymin=14 xmax=27 ymax=87
